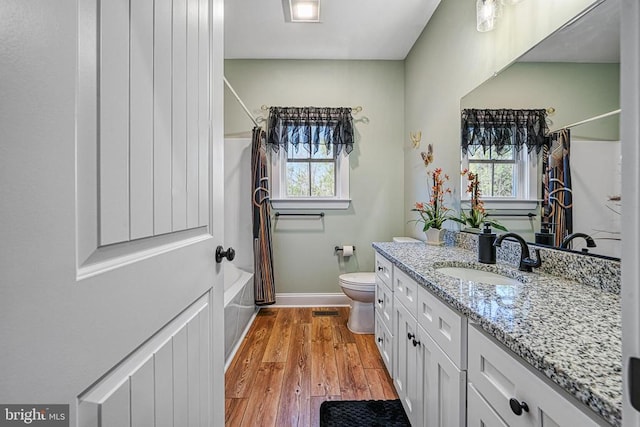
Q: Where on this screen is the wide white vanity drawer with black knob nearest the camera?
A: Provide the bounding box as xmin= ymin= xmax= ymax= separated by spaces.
xmin=469 ymin=325 xmax=606 ymax=427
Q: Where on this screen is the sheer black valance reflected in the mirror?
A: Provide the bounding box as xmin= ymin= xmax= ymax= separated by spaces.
xmin=461 ymin=109 xmax=549 ymax=154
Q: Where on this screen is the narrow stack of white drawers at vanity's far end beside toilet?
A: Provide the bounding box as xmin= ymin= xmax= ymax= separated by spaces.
xmin=375 ymin=253 xmax=393 ymax=378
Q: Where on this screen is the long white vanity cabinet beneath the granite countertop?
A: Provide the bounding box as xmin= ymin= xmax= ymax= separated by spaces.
xmin=375 ymin=254 xmax=609 ymax=427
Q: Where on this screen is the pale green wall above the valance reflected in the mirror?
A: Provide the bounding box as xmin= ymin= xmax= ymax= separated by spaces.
xmin=460 ymin=62 xmax=620 ymax=141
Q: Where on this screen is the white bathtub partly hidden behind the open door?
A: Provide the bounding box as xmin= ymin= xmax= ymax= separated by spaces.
xmin=224 ymin=262 xmax=257 ymax=370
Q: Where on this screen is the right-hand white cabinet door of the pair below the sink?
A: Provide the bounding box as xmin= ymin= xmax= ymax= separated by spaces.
xmin=416 ymin=326 xmax=467 ymax=427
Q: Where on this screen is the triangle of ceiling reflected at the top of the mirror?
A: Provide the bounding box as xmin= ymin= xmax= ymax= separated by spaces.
xmin=518 ymin=0 xmax=620 ymax=63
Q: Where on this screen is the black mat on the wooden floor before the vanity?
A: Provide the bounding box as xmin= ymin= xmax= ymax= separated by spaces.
xmin=320 ymin=400 xmax=411 ymax=427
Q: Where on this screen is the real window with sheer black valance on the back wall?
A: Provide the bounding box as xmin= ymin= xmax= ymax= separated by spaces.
xmin=268 ymin=107 xmax=353 ymax=209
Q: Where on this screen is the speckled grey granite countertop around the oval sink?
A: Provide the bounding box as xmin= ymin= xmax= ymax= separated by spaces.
xmin=373 ymin=242 xmax=622 ymax=426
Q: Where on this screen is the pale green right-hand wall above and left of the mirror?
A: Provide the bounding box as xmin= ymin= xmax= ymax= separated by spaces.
xmin=404 ymin=0 xmax=593 ymax=237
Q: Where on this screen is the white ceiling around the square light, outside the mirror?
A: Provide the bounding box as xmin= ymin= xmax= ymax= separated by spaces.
xmin=224 ymin=0 xmax=440 ymax=60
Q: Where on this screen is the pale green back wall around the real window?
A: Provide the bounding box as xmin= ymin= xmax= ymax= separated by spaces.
xmin=225 ymin=60 xmax=405 ymax=293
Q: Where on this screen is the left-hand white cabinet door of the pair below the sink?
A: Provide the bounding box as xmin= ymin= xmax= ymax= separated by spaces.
xmin=393 ymin=300 xmax=420 ymax=426
